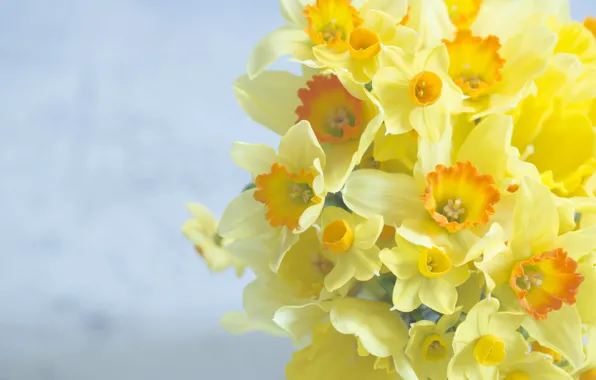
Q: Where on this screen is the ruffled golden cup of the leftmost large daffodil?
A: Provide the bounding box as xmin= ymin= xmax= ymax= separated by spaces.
xmin=254 ymin=163 xmax=321 ymax=229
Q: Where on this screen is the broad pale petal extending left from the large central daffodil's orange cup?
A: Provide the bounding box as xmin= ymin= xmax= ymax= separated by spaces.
xmin=343 ymin=169 xmax=426 ymax=224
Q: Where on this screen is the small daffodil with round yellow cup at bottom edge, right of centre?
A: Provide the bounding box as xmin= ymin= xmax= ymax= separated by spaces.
xmin=448 ymin=298 xmax=528 ymax=380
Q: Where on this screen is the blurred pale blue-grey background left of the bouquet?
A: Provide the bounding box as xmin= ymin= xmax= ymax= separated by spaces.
xmin=0 ymin=0 xmax=596 ymax=380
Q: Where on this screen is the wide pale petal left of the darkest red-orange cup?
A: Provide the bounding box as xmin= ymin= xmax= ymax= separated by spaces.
xmin=233 ymin=71 xmax=308 ymax=135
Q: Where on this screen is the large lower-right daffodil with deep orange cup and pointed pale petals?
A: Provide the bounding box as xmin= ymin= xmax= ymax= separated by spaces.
xmin=477 ymin=179 xmax=596 ymax=368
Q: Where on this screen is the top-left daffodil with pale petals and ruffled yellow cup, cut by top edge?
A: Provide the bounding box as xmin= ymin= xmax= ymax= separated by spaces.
xmin=247 ymin=0 xmax=407 ymax=78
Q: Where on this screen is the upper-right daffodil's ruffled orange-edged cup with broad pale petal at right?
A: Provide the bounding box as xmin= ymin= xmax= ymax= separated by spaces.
xmin=445 ymin=25 xmax=556 ymax=117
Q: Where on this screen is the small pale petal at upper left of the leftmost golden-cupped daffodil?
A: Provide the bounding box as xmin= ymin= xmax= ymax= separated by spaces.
xmin=230 ymin=141 xmax=278 ymax=179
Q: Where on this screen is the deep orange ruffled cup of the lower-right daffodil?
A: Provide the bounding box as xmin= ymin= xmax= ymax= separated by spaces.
xmin=509 ymin=248 xmax=584 ymax=320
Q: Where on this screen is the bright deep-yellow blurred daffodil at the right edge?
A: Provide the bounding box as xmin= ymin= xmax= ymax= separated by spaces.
xmin=513 ymin=25 xmax=596 ymax=196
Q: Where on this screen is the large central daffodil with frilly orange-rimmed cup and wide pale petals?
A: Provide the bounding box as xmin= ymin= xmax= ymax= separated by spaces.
xmin=343 ymin=115 xmax=520 ymax=255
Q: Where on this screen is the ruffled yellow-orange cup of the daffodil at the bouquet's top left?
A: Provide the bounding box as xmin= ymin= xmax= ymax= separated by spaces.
xmin=303 ymin=0 xmax=362 ymax=50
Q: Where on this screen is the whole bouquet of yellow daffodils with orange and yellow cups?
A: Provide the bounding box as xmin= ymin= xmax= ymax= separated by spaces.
xmin=183 ymin=0 xmax=596 ymax=380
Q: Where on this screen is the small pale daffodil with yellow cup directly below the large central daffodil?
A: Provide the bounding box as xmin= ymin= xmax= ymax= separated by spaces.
xmin=381 ymin=237 xmax=469 ymax=314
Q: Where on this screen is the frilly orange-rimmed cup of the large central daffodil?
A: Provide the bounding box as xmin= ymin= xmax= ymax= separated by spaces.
xmin=422 ymin=161 xmax=500 ymax=232
